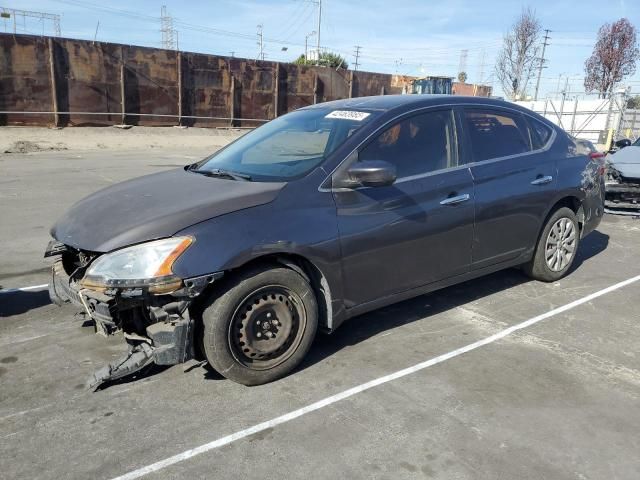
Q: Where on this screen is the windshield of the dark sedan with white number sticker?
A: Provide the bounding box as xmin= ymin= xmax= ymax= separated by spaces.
xmin=193 ymin=108 xmax=375 ymax=181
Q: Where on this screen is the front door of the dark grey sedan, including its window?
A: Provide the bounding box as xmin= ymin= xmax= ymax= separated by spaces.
xmin=333 ymin=109 xmax=474 ymax=308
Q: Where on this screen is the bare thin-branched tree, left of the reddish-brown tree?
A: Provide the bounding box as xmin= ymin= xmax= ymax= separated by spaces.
xmin=496 ymin=8 xmax=542 ymax=100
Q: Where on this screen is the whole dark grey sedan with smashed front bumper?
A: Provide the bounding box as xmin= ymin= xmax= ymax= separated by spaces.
xmin=46 ymin=95 xmax=604 ymax=386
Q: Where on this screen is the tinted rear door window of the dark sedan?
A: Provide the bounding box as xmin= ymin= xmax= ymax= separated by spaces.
xmin=464 ymin=109 xmax=531 ymax=162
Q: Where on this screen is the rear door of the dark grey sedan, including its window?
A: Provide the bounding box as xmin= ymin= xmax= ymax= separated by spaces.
xmin=460 ymin=107 xmax=557 ymax=269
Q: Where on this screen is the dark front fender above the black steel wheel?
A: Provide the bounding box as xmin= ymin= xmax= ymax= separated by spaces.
xmin=168 ymin=193 xmax=342 ymax=308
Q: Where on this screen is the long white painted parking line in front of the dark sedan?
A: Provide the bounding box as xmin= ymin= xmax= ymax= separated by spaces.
xmin=112 ymin=275 xmax=640 ymax=480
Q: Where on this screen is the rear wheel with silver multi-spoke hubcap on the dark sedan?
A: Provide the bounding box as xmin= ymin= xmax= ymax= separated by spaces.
xmin=523 ymin=207 xmax=580 ymax=282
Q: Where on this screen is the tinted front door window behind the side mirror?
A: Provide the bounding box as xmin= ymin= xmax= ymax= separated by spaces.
xmin=358 ymin=110 xmax=457 ymax=179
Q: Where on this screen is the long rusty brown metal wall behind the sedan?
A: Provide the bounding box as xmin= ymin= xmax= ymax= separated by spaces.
xmin=0 ymin=33 xmax=412 ymax=127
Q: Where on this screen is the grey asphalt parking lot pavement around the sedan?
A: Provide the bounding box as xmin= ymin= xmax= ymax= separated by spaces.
xmin=0 ymin=150 xmax=640 ymax=480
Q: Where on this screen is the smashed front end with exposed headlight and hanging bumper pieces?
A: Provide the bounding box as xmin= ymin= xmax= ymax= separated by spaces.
xmin=45 ymin=237 xmax=222 ymax=389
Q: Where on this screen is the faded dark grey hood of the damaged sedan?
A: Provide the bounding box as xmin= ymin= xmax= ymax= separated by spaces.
xmin=51 ymin=169 xmax=285 ymax=252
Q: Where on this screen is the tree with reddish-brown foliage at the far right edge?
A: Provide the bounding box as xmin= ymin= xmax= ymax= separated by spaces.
xmin=584 ymin=18 xmax=640 ymax=98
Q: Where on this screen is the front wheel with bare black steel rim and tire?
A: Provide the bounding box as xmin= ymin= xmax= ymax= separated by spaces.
xmin=202 ymin=267 xmax=318 ymax=385
